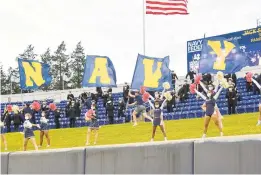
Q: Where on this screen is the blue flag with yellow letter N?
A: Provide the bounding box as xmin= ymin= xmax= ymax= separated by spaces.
xmin=18 ymin=58 xmax=52 ymax=89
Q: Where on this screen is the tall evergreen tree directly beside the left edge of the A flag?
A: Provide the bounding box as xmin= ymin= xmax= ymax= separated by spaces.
xmin=70 ymin=42 xmax=85 ymax=88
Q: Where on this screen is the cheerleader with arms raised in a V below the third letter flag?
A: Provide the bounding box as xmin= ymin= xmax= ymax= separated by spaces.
xmin=146 ymin=99 xmax=167 ymax=142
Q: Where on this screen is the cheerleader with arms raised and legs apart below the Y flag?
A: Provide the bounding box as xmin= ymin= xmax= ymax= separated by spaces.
xmin=195 ymin=87 xmax=223 ymax=138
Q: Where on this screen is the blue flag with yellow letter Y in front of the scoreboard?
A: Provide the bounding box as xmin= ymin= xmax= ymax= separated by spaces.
xmin=198 ymin=37 xmax=248 ymax=74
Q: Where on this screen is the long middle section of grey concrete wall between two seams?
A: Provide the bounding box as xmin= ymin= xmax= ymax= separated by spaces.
xmin=86 ymin=141 xmax=193 ymax=174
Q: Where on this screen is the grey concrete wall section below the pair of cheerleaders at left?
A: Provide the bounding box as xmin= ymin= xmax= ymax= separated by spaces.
xmin=8 ymin=148 xmax=85 ymax=174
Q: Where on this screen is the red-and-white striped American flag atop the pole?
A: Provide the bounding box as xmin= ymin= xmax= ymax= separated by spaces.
xmin=146 ymin=0 xmax=188 ymax=15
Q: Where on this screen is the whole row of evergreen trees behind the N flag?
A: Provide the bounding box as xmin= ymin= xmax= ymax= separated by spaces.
xmin=0 ymin=41 xmax=85 ymax=95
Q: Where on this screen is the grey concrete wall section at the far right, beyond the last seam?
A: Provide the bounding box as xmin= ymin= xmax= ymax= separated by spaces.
xmin=194 ymin=135 xmax=261 ymax=174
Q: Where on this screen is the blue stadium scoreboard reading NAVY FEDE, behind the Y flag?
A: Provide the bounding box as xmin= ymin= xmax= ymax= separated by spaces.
xmin=187 ymin=27 xmax=261 ymax=71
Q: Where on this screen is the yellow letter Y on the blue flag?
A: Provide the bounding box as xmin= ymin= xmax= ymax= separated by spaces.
xmin=208 ymin=41 xmax=236 ymax=70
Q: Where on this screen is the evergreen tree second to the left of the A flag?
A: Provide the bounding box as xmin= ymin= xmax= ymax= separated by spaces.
xmin=52 ymin=41 xmax=71 ymax=90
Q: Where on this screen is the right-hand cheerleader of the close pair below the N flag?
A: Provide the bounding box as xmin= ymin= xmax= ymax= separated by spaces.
xmin=39 ymin=111 xmax=50 ymax=147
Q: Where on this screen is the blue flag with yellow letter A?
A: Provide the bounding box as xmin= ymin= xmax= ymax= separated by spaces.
xmin=82 ymin=55 xmax=117 ymax=87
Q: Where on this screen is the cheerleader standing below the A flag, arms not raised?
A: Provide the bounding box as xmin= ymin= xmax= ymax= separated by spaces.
xmin=86 ymin=104 xmax=100 ymax=146
